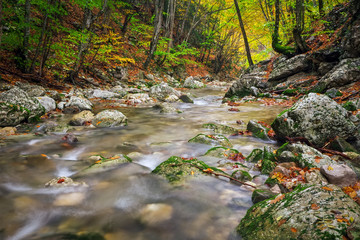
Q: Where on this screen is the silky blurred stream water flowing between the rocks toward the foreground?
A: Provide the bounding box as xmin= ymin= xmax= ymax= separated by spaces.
xmin=0 ymin=89 xmax=282 ymax=240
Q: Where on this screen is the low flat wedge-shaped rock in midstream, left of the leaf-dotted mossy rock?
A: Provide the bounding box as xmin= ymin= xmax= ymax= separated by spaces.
xmin=76 ymin=154 xmax=132 ymax=177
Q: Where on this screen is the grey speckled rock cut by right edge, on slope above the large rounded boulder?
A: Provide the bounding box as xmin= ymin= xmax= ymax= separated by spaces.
xmin=312 ymin=58 xmax=360 ymax=92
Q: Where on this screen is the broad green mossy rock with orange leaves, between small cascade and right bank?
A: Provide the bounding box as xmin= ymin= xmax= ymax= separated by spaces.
xmin=152 ymin=156 xmax=225 ymax=183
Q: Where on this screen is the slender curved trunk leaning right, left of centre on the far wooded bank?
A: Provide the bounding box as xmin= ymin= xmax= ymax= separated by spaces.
xmin=143 ymin=0 xmax=164 ymax=69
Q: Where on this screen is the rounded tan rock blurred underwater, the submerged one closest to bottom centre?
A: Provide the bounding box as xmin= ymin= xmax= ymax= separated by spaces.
xmin=139 ymin=203 xmax=173 ymax=227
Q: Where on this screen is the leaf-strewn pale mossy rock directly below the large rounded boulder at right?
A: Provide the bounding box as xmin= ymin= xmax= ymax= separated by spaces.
xmin=276 ymin=143 xmax=335 ymax=168
